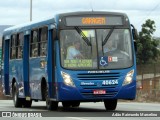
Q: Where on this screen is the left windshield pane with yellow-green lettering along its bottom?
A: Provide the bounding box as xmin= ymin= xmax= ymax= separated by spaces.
xmin=60 ymin=29 xmax=97 ymax=69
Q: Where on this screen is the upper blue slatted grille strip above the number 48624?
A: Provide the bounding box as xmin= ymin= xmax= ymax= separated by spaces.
xmin=77 ymin=73 xmax=120 ymax=80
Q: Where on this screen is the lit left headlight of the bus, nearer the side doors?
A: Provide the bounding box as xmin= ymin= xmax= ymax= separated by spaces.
xmin=61 ymin=71 xmax=75 ymax=87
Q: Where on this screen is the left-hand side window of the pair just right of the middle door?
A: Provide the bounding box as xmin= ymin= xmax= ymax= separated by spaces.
xmin=30 ymin=29 xmax=38 ymax=57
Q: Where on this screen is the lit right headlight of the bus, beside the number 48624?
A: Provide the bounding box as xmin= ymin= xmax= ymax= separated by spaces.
xmin=122 ymin=70 xmax=134 ymax=86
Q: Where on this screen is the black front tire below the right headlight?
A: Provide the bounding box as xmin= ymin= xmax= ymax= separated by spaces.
xmin=104 ymin=99 xmax=117 ymax=110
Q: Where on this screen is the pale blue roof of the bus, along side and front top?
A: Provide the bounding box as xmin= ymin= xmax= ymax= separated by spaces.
xmin=3 ymin=11 xmax=127 ymax=35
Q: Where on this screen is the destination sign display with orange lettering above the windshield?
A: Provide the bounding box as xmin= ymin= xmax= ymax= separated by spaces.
xmin=65 ymin=16 xmax=123 ymax=26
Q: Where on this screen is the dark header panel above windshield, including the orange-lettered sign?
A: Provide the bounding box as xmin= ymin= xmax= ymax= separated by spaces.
xmin=56 ymin=11 xmax=129 ymax=29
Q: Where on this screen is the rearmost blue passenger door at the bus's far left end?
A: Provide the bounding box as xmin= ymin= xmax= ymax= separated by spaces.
xmin=4 ymin=39 xmax=10 ymax=95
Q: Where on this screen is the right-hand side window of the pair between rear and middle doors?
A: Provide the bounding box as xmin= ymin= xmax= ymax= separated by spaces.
xmin=17 ymin=33 xmax=24 ymax=59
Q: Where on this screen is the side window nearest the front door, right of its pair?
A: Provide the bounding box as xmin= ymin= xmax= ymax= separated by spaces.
xmin=40 ymin=27 xmax=48 ymax=56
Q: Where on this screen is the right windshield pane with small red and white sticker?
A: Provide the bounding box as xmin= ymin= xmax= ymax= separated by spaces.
xmin=97 ymin=29 xmax=133 ymax=69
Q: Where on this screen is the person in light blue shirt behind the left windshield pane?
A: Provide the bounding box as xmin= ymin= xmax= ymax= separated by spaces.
xmin=66 ymin=41 xmax=84 ymax=59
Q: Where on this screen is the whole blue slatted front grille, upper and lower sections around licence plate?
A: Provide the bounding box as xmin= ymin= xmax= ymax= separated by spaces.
xmin=77 ymin=72 xmax=122 ymax=99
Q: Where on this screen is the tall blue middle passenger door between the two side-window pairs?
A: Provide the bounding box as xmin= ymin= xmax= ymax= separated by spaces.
xmin=23 ymin=31 xmax=30 ymax=99
